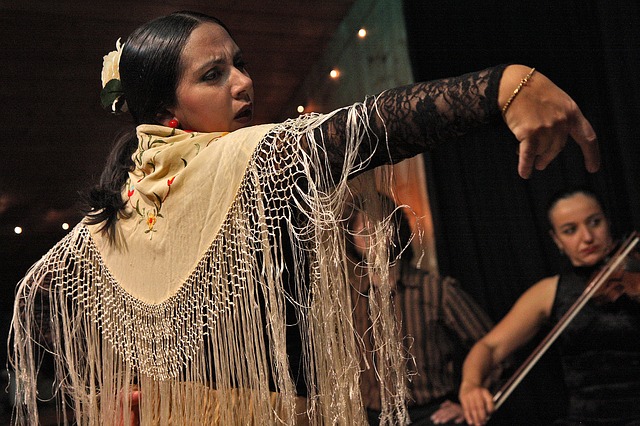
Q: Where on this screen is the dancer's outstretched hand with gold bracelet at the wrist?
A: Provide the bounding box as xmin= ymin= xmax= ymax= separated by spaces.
xmin=498 ymin=65 xmax=600 ymax=179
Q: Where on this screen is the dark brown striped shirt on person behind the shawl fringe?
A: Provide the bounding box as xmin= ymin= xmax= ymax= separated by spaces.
xmin=352 ymin=265 xmax=493 ymax=410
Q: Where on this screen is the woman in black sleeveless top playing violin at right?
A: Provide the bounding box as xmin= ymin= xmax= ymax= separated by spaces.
xmin=460 ymin=189 xmax=640 ymax=425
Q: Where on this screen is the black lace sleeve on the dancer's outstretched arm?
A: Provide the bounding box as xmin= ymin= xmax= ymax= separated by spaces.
xmin=320 ymin=65 xmax=506 ymax=176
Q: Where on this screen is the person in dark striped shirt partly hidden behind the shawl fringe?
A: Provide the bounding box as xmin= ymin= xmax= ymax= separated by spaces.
xmin=347 ymin=205 xmax=500 ymax=425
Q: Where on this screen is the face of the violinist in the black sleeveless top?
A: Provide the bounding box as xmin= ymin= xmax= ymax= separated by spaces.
xmin=549 ymin=192 xmax=612 ymax=266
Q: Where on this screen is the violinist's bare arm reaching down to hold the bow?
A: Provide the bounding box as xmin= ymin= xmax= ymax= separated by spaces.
xmin=459 ymin=276 xmax=558 ymax=425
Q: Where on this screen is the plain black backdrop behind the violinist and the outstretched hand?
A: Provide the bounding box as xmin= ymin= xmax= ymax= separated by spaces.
xmin=404 ymin=0 xmax=640 ymax=425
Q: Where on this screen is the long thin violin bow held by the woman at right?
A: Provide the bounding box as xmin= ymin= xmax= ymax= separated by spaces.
xmin=493 ymin=231 xmax=640 ymax=410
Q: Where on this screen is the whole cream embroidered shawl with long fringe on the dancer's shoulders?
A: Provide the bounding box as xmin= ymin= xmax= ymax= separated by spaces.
xmin=11 ymin=105 xmax=407 ymax=425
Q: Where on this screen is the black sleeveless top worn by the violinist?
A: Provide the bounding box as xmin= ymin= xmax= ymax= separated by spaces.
xmin=551 ymin=268 xmax=640 ymax=425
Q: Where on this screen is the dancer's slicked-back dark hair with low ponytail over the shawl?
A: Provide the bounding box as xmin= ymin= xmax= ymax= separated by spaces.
xmin=83 ymin=11 xmax=229 ymax=239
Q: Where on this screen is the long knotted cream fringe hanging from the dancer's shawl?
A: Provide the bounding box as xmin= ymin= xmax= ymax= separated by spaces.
xmin=10 ymin=99 xmax=407 ymax=425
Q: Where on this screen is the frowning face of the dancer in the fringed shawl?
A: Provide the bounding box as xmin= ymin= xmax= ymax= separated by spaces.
xmin=164 ymin=22 xmax=253 ymax=132
